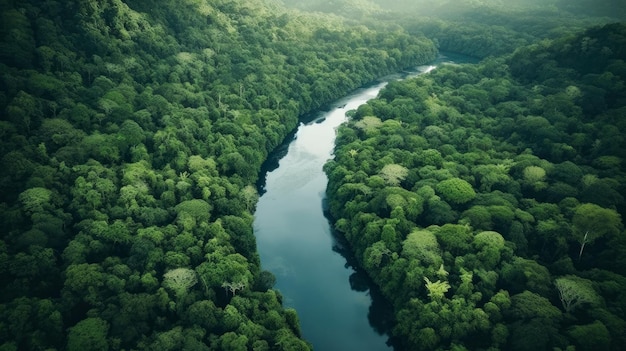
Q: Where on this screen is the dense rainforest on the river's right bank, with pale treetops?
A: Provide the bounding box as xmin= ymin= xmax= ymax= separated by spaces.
xmin=325 ymin=15 xmax=626 ymax=350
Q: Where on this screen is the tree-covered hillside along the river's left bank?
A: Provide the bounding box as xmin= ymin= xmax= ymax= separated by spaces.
xmin=0 ymin=0 xmax=436 ymax=350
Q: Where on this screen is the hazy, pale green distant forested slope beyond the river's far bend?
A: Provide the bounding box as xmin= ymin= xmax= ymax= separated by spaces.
xmin=283 ymin=0 xmax=626 ymax=58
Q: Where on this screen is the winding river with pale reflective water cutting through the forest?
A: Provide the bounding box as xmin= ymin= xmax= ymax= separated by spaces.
xmin=254 ymin=55 xmax=467 ymax=351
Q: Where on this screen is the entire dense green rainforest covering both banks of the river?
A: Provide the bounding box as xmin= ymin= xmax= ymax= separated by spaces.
xmin=0 ymin=0 xmax=626 ymax=351
